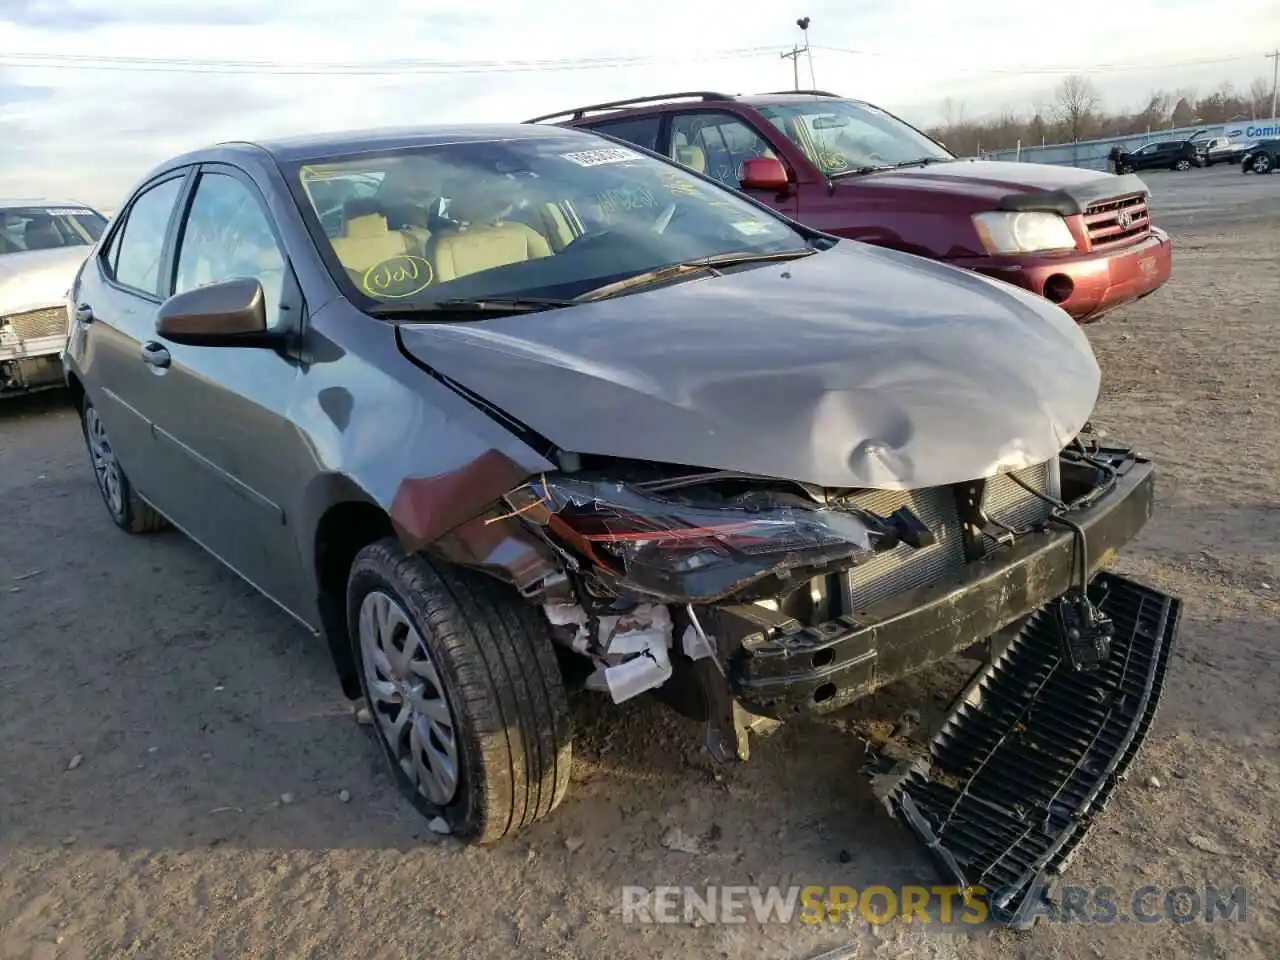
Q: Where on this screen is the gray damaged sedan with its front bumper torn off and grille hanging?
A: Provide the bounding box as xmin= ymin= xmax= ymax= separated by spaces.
xmin=65 ymin=125 xmax=1179 ymax=918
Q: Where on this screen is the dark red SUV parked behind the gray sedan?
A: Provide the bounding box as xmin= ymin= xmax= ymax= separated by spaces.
xmin=529 ymin=91 xmax=1172 ymax=323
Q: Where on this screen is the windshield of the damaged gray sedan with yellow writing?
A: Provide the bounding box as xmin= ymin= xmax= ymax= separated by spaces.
xmin=287 ymin=133 xmax=806 ymax=310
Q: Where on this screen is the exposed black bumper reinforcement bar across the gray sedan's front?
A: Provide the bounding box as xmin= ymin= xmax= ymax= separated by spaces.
xmin=712 ymin=457 xmax=1156 ymax=719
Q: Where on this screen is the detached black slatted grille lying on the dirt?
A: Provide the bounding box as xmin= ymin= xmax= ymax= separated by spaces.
xmin=867 ymin=573 xmax=1181 ymax=928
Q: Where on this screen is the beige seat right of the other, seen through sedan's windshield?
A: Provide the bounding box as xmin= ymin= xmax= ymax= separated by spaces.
xmin=426 ymin=191 xmax=552 ymax=283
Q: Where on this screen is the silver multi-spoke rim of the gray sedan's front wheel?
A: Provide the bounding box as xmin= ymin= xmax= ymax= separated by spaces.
xmin=357 ymin=590 xmax=458 ymax=805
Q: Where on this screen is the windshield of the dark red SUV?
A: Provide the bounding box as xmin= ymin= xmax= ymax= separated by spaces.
xmin=758 ymin=97 xmax=955 ymax=177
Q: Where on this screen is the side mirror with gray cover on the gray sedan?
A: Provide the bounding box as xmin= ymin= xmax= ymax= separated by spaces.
xmin=156 ymin=278 xmax=275 ymax=347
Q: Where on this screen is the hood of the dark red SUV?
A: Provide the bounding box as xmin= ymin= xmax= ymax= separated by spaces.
xmin=835 ymin=160 xmax=1147 ymax=216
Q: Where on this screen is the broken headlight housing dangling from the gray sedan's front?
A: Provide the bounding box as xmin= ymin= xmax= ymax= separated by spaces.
xmin=507 ymin=475 xmax=932 ymax=603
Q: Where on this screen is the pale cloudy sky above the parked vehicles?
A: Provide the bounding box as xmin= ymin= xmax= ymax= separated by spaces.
xmin=0 ymin=0 xmax=1280 ymax=207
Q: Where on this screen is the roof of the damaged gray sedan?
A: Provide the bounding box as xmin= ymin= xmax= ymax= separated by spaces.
xmin=154 ymin=123 xmax=609 ymax=173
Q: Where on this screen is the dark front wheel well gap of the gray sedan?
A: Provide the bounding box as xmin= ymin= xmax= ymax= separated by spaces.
xmin=315 ymin=502 xmax=394 ymax=699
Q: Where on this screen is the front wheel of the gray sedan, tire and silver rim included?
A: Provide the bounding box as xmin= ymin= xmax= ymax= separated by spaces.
xmin=347 ymin=538 xmax=572 ymax=845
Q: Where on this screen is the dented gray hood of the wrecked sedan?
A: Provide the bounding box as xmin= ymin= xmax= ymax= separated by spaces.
xmin=401 ymin=241 xmax=1100 ymax=489
